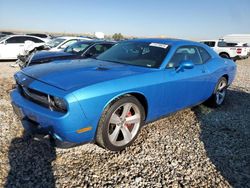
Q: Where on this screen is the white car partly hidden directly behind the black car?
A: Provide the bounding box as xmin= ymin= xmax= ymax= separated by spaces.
xmin=46 ymin=37 xmax=91 ymax=52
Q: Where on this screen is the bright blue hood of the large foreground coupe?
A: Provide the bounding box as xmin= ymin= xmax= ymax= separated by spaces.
xmin=22 ymin=59 xmax=151 ymax=91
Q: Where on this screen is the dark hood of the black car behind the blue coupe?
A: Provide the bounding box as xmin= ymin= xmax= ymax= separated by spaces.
xmin=32 ymin=51 xmax=75 ymax=61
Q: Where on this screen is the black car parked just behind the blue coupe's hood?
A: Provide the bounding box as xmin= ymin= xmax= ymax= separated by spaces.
xmin=21 ymin=40 xmax=115 ymax=68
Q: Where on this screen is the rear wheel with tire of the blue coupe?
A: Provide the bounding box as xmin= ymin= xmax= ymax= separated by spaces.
xmin=205 ymin=77 xmax=228 ymax=108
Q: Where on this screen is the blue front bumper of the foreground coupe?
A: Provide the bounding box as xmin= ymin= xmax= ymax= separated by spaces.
xmin=10 ymin=89 xmax=95 ymax=144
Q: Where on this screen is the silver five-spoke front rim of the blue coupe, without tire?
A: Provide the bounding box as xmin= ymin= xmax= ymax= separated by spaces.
xmin=108 ymin=103 xmax=141 ymax=146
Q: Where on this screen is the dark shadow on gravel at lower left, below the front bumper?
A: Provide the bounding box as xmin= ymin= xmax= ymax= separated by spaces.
xmin=5 ymin=133 xmax=56 ymax=188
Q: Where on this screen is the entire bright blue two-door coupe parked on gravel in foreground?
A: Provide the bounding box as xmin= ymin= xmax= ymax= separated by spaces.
xmin=11 ymin=39 xmax=236 ymax=151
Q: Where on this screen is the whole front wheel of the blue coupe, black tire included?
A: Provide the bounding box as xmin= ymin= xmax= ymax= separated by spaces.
xmin=96 ymin=95 xmax=145 ymax=151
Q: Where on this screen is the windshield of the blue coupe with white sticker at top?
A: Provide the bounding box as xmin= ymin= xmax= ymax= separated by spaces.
xmin=97 ymin=41 xmax=169 ymax=68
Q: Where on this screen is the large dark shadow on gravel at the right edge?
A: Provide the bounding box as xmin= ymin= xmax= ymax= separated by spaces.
xmin=192 ymin=88 xmax=250 ymax=187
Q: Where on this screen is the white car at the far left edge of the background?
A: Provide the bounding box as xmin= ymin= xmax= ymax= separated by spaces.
xmin=0 ymin=35 xmax=45 ymax=60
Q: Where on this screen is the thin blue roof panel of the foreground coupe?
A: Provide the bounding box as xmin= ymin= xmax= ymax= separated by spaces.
xmin=127 ymin=38 xmax=202 ymax=45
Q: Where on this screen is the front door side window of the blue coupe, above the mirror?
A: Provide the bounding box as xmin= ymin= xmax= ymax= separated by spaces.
xmin=167 ymin=46 xmax=202 ymax=68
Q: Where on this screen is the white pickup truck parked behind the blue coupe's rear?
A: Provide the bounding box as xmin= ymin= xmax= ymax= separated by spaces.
xmin=200 ymin=40 xmax=248 ymax=61
